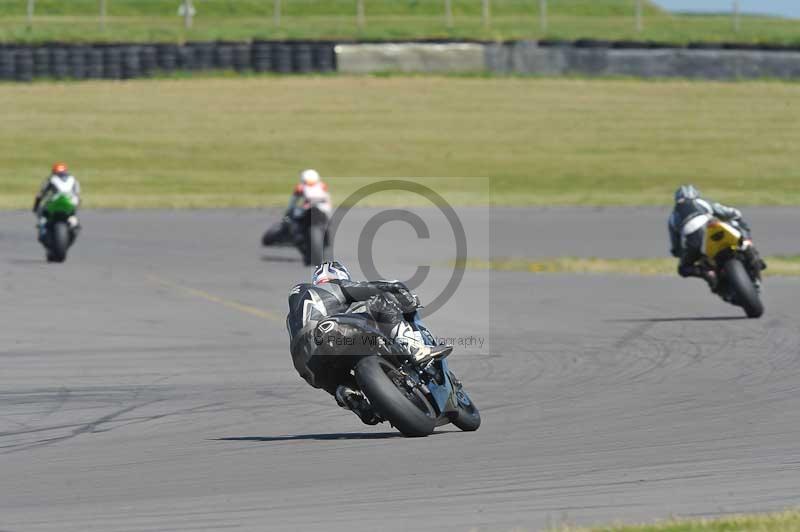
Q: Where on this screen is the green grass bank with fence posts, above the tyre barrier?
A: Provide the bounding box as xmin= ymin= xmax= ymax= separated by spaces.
xmin=0 ymin=0 xmax=800 ymax=44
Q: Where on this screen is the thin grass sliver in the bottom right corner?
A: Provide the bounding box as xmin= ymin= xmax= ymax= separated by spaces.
xmin=556 ymin=511 xmax=800 ymax=532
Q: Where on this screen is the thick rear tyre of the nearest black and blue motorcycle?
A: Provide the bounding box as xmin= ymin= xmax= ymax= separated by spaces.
xmin=355 ymin=355 xmax=436 ymax=437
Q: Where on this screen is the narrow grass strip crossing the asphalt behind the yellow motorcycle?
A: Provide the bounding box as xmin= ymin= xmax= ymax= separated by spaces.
xmin=466 ymin=256 xmax=800 ymax=276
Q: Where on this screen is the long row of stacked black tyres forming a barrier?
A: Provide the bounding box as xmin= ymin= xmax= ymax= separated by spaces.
xmin=0 ymin=41 xmax=336 ymax=81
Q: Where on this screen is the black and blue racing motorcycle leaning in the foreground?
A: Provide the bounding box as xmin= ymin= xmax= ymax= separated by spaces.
xmin=314 ymin=312 xmax=481 ymax=437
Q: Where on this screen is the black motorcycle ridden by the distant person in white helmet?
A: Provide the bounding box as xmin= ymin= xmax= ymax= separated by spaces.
xmin=261 ymin=203 xmax=330 ymax=266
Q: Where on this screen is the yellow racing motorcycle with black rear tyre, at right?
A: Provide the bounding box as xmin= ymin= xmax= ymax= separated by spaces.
xmin=702 ymin=217 xmax=764 ymax=318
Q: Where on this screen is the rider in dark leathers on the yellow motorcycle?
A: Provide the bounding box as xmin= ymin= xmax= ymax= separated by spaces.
xmin=668 ymin=185 xmax=767 ymax=291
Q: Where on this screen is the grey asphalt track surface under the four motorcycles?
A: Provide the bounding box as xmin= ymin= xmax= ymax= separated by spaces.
xmin=0 ymin=209 xmax=800 ymax=532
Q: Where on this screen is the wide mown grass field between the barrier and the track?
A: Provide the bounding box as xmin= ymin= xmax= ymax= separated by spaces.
xmin=0 ymin=76 xmax=800 ymax=208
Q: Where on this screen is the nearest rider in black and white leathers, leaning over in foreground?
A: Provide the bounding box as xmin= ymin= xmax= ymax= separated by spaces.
xmin=286 ymin=261 xmax=452 ymax=425
